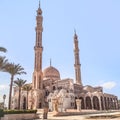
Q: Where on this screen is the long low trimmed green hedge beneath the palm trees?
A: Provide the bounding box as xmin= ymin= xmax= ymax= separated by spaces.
xmin=4 ymin=110 xmax=37 ymax=114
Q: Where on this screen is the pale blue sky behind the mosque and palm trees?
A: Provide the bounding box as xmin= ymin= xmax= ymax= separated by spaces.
xmin=0 ymin=0 xmax=120 ymax=104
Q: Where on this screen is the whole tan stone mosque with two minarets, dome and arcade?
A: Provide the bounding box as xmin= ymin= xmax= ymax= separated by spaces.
xmin=12 ymin=5 xmax=118 ymax=111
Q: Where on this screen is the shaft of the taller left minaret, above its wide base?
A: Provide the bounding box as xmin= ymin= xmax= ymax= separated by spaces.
xmin=32 ymin=2 xmax=43 ymax=89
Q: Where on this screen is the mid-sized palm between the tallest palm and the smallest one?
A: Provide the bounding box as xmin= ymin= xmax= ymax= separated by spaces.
xmin=14 ymin=78 xmax=26 ymax=109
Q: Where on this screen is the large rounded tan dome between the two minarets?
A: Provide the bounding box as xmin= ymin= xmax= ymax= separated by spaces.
xmin=43 ymin=66 xmax=60 ymax=80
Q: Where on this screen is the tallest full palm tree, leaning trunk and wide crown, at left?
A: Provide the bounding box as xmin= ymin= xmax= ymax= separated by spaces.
xmin=4 ymin=63 xmax=26 ymax=109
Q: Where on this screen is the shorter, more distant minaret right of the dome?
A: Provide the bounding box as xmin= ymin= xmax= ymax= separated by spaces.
xmin=74 ymin=32 xmax=82 ymax=85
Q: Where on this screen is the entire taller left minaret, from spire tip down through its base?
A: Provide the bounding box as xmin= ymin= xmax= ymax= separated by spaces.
xmin=32 ymin=2 xmax=44 ymax=109
